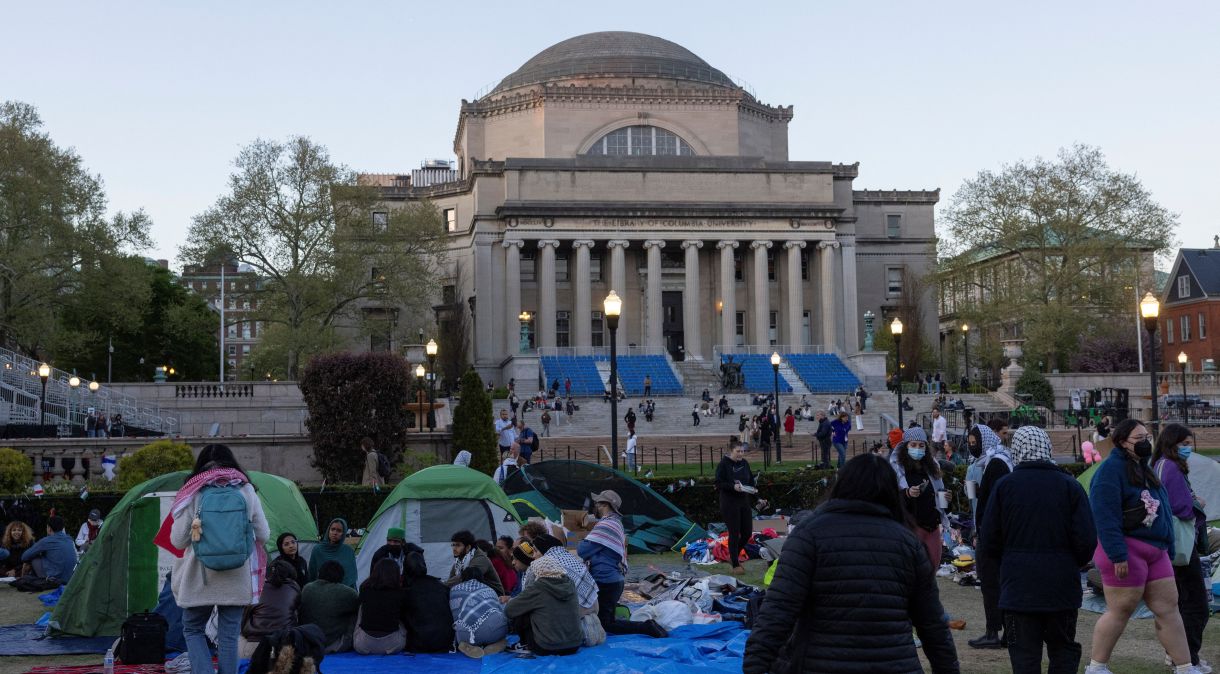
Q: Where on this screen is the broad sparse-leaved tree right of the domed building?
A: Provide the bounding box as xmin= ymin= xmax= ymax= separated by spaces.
xmin=941 ymin=145 xmax=1177 ymax=369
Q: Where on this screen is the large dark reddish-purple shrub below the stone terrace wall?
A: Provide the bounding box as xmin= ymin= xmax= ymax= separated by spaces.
xmin=298 ymin=353 xmax=414 ymax=482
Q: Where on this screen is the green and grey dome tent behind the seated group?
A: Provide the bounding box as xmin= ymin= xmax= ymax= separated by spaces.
xmin=356 ymin=464 xmax=521 ymax=581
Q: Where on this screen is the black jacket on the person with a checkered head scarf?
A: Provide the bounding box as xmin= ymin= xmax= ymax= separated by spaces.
xmin=980 ymin=462 xmax=1097 ymax=613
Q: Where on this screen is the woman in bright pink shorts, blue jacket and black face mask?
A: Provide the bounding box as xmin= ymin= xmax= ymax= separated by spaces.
xmin=1085 ymin=419 xmax=1199 ymax=674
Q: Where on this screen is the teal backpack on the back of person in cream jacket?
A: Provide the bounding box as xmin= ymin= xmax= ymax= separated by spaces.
xmin=192 ymin=486 xmax=254 ymax=571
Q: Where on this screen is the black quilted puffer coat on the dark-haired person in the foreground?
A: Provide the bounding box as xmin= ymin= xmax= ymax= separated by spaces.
xmin=742 ymin=499 xmax=959 ymax=674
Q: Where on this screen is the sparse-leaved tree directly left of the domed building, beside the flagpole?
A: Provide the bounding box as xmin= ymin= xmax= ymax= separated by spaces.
xmin=181 ymin=137 xmax=444 ymax=379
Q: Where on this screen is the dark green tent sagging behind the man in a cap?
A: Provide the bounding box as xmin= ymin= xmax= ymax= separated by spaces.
xmin=504 ymin=460 xmax=708 ymax=553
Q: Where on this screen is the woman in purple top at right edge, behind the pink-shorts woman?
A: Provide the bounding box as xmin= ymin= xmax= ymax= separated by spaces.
xmin=1152 ymin=424 xmax=1210 ymax=669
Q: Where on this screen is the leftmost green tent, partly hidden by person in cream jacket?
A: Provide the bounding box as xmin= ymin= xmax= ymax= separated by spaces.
xmin=51 ymin=470 xmax=318 ymax=636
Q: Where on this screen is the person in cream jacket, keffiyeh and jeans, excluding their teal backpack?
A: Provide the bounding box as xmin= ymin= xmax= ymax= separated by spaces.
xmin=154 ymin=444 xmax=271 ymax=674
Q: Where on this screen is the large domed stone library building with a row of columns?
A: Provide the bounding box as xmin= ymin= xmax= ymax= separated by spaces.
xmin=365 ymin=32 xmax=939 ymax=394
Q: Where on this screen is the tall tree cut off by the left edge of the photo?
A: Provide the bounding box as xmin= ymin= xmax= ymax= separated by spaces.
xmin=0 ymin=101 xmax=151 ymax=358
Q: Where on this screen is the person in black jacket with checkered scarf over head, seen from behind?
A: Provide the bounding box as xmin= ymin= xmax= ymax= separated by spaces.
xmin=971 ymin=426 xmax=1102 ymax=674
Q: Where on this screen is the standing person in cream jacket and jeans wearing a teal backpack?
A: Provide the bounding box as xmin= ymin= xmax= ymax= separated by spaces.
xmin=155 ymin=444 xmax=271 ymax=674
